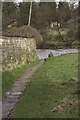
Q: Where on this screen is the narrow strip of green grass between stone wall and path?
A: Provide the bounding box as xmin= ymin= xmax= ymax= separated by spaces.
xmin=2 ymin=60 xmax=38 ymax=93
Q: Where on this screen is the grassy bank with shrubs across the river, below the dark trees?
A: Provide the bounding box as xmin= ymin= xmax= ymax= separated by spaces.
xmin=39 ymin=28 xmax=80 ymax=49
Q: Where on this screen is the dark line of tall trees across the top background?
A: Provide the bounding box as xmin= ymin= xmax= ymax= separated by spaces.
xmin=2 ymin=2 xmax=79 ymax=29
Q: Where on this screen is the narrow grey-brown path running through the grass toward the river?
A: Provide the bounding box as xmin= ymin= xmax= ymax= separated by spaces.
xmin=2 ymin=60 xmax=44 ymax=118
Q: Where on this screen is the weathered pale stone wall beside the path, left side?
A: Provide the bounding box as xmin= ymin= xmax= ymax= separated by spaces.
xmin=0 ymin=37 xmax=37 ymax=70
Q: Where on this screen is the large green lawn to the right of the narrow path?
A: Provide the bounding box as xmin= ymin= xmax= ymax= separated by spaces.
xmin=12 ymin=54 xmax=78 ymax=118
